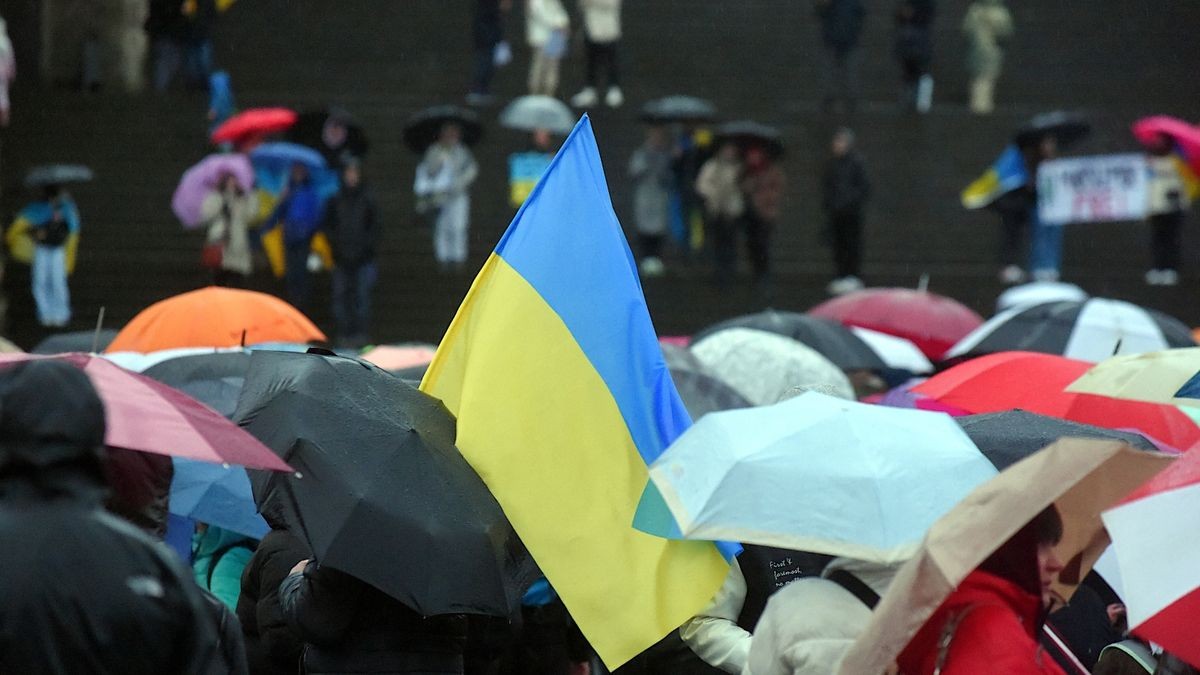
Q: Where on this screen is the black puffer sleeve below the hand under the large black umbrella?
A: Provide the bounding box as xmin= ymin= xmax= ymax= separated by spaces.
xmin=280 ymin=562 xmax=360 ymax=645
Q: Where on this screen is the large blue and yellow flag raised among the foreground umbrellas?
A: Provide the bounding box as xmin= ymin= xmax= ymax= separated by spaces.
xmin=421 ymin=115 xmax=730 ymax=668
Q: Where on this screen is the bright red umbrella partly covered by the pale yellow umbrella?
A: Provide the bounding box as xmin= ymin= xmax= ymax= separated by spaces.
xmin=912 ymin=352 xmax=1200 ymax=449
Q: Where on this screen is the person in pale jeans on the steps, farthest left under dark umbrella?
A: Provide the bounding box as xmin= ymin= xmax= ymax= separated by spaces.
xmin=18 ymin=185 xmax=79 ymax=328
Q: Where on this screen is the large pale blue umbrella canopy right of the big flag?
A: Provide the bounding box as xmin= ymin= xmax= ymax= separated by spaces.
xmin=650 ymin=392 xmax=996 ymax=563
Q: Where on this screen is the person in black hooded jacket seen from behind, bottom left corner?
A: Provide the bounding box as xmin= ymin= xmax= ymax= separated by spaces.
xmin=0 ymin=360 xmax=224 ymax=675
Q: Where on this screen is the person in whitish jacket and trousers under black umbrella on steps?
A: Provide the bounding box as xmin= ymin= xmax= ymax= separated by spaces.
xmin=413 ymin=123 xmax=479 ymax=271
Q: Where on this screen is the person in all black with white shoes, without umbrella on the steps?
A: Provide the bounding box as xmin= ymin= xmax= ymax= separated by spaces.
xmin=822 ymin=127 xmax=871 ymax=294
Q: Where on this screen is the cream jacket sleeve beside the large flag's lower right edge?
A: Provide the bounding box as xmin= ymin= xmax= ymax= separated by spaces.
xmin=679 ymin=561 xmax=750 ymax=675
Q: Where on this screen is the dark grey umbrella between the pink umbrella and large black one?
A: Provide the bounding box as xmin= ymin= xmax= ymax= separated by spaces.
xmin=142 ymin=352 xmax=250 ymax=418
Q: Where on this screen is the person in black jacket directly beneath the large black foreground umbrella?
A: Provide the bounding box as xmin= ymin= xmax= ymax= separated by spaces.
xmin=280 ymin=561 xmax=467 ymax=675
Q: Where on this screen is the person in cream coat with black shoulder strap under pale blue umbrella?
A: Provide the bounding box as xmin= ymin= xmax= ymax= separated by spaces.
xmin=743 ymin=557 xmax=900 ymax=675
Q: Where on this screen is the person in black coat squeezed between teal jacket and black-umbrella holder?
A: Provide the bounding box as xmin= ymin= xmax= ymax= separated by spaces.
xmin=238 ymin=509 xmax=311 ymax=675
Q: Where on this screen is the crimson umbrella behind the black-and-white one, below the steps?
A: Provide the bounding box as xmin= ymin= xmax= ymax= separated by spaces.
xmin=809 ymin=288 xmax=983 ymax=360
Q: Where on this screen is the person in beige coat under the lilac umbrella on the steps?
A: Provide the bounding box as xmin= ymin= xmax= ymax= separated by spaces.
xmin=200 ymin=175 xmax=258 ymax=287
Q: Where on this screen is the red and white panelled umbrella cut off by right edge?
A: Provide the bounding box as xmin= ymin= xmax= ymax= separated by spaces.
xmin=1103 ymin=452 xmax=1200 ymax=668
